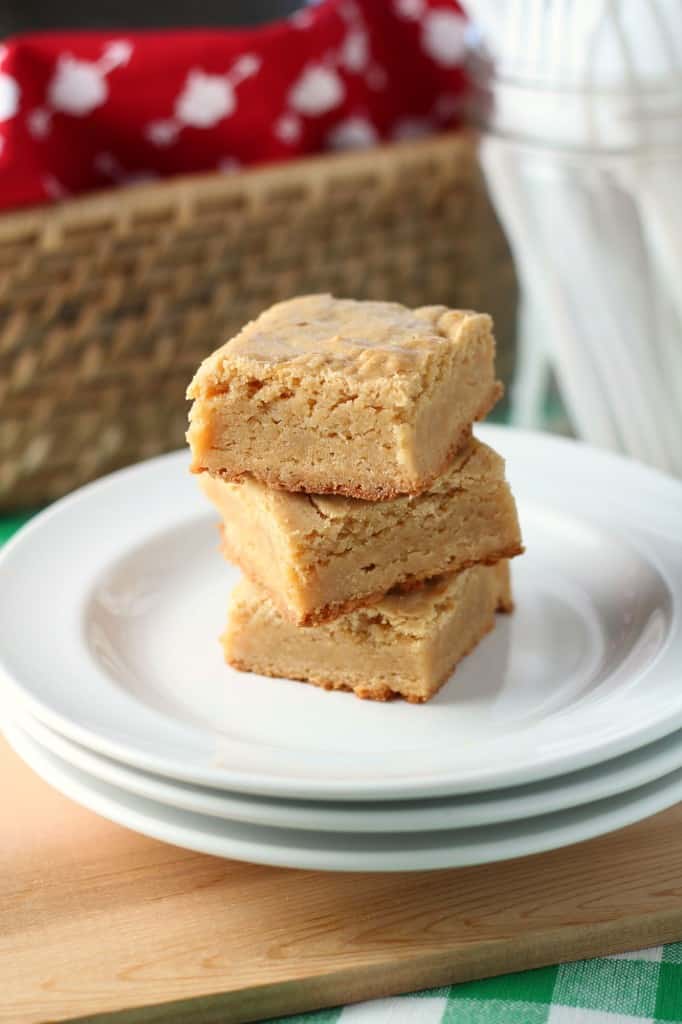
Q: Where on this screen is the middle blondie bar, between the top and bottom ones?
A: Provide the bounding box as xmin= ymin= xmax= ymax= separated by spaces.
xmin=200 ymin=438 xmax=522 ymax=626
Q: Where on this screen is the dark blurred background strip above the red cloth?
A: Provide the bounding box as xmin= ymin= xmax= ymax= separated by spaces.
xmin=0 ymin=0 xmax=303 ymax=38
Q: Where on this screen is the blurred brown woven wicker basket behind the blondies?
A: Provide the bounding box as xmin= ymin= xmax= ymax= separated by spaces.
xmin=0 ymin=134 xmax=516 ymax=509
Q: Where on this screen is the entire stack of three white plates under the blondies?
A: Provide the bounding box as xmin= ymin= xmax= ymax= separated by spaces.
xmin=0 ymin=427 xmax=682 ymax=870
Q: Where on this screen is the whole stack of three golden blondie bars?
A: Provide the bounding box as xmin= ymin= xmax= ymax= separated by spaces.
xmin=187 ymin=295 xmax=522 ymax=701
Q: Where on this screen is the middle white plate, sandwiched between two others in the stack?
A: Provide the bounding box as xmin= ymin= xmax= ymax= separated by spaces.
xmin=10 ymin=715 xmax=682 ymax=833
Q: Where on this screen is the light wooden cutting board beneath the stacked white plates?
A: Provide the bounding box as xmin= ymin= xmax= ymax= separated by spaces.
xmin=0 ymin=740 xmax=682 ymax=1024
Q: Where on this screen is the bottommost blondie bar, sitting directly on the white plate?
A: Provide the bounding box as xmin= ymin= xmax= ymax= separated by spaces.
xmin=221 ymin=561 xmax=512 ymax=702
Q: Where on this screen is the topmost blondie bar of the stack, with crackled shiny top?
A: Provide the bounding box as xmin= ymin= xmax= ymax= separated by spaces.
xmin=187 ymin=295 xmax=502 ymax=501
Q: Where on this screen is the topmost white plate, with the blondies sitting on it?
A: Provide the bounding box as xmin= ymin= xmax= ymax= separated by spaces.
xmin=0 ymin=427 xmax=682 ymax=800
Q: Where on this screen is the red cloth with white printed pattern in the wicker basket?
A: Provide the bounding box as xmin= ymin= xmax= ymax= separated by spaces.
xmin=0 ymin=0 xmax=467 ymax=209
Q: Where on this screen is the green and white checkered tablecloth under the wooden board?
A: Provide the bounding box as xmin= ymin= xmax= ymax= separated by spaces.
xmin=5 ymin=515 xmax=682 ymax=1024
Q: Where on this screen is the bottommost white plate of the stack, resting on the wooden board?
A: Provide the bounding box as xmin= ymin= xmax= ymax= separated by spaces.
xmin=6 ymin=726 xmax=682 ymax=871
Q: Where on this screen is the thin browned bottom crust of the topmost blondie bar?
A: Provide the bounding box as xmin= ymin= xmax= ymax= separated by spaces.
xmin=190 ymin=381 xmax=504 ymax=502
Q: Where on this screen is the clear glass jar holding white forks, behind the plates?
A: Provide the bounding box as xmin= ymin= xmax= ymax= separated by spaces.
xmin=464 ymin=3 xmax=682 ymax=476
